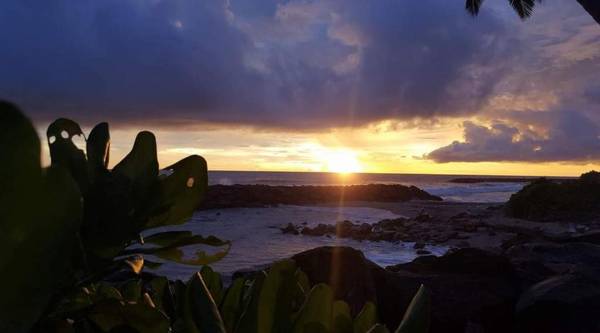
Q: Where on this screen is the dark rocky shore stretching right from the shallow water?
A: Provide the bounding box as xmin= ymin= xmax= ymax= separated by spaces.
xmin=278 ymin=200 xmax=600 ymax=253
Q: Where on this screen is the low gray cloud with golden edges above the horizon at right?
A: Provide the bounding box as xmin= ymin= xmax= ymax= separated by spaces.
xmin=425 ymin=111 xmax=600 ymax=163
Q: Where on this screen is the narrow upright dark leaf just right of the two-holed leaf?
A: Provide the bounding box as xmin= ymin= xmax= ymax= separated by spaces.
xmin=86 ymin=123 xmax=110 ymax=180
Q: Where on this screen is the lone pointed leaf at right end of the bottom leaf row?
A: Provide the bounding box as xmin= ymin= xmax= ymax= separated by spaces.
xmin=396 ymin=285 xmax=431 ymax=333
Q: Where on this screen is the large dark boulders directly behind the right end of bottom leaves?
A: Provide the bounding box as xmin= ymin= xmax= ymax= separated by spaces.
xmin=293 ymin=247 xmax=518 ymax=333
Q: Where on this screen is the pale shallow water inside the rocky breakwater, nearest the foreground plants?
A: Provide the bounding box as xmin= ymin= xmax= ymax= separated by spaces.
xmin=144 ymin=204 xmax=445 ymax=280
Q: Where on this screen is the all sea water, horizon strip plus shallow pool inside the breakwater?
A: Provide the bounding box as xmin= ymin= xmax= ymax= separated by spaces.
xmin=146 ymin=171 xmax=524 ymax=281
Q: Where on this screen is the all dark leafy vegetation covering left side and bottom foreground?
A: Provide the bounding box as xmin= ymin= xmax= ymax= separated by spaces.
xmin=0 ymin=102 xmax=430 ymax=333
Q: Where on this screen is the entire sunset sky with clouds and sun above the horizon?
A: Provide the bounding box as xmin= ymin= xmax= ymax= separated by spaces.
xmin=0 ymin=0 xmax=600 ymax=176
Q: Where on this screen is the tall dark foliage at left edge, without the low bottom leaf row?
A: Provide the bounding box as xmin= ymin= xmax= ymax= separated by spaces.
xmin=0 ymin=102 xmax=230 ymax=332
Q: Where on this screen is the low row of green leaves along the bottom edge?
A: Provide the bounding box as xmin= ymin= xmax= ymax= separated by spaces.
xmin=39 ymin=260 xmax=430 ymax=333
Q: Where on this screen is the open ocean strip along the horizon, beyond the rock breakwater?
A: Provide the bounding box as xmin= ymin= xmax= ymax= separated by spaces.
xmin=208 ymin=171 xmax=524 ymax=202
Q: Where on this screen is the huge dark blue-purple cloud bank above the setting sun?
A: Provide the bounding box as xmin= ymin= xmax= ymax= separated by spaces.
xmin=0 ymin=0 xmax=520 ymax=129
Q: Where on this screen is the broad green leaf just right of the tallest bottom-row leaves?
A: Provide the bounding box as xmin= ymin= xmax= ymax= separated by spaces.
xmin=293 ymin=283 xmax=333 ymax=333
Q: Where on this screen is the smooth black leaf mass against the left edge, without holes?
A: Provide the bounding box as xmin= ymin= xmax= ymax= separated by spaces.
xmin=0 ymin=102 xmax=82 ymax=332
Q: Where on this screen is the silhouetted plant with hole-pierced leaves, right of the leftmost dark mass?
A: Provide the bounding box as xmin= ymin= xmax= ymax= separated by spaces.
xmin=47 ymin=118 xmax=229 ymax=270
